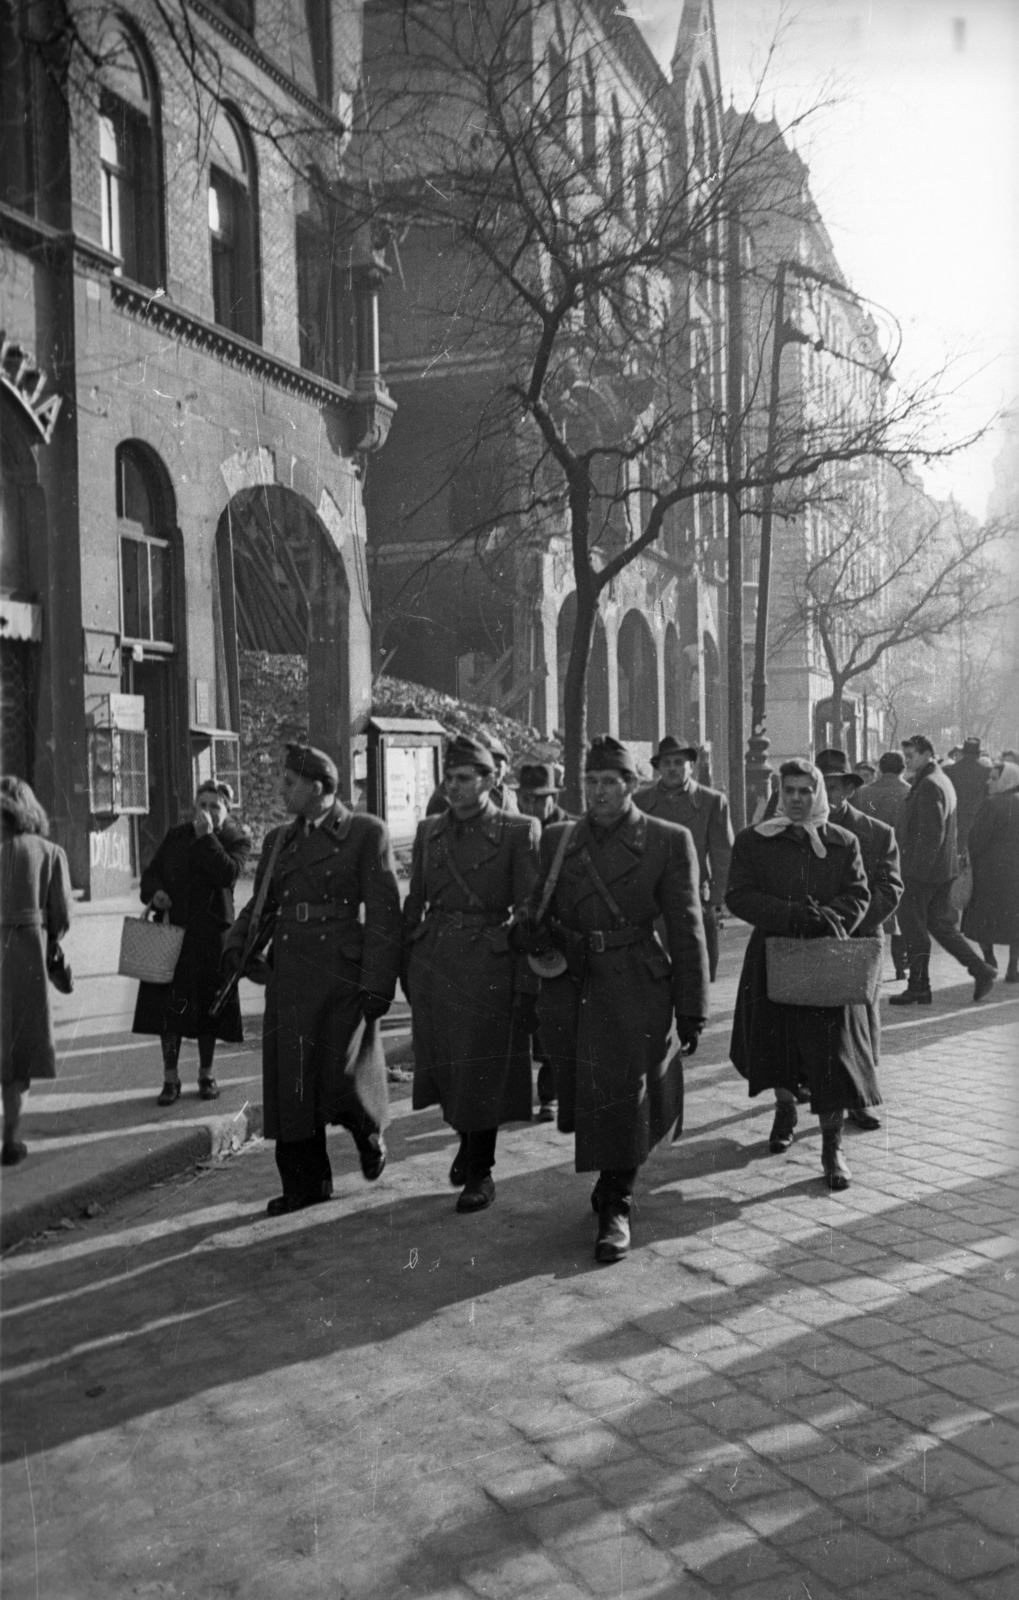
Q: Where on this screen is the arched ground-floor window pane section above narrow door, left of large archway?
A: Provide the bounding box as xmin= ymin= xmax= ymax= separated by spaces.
xmin=117 ymin=445 xmax=173 ymax=645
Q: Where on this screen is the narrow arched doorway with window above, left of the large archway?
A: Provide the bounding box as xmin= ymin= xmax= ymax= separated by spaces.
xmin=115 ymin=438 xmax=190 ymax=872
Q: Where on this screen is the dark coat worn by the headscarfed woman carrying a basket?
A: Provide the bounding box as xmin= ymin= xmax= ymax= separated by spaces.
xmin=726 ymin=822 xmax=881 ymax=1115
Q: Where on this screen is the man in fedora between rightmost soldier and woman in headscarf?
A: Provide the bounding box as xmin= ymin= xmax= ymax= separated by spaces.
xmin=633 ymin=733 xmax=733 ymax=982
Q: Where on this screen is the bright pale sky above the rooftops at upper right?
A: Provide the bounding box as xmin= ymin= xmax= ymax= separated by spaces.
xmin=629 ymin=0 xmax=1019 ymax=517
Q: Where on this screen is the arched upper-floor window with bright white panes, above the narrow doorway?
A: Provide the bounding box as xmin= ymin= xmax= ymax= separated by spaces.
xmin=99 ymin=29 xmax=166 ymax=288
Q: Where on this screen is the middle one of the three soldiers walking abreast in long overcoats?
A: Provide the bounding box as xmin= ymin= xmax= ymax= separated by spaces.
xmin=403 ymin=736 xmax=539 ymax=1211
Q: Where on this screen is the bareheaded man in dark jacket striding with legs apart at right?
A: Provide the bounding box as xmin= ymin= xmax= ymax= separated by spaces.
xmin=889 ymin=733 xmax=995 ymax=1005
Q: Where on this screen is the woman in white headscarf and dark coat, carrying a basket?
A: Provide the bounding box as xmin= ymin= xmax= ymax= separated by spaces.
xmin=725 ymin=758 xmax=881 ymax=1189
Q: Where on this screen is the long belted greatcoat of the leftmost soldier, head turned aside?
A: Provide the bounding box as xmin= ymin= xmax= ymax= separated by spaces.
xmin=226 ymin=808 xmax=400 ymax=1142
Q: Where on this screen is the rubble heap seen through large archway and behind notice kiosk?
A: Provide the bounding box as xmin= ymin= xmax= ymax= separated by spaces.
xmin=238 ymin=650 xmax=561 ymax=850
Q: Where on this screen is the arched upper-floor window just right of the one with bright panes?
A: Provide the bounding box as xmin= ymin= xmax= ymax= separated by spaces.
xmin=208 ymin=106 xmax=262 ymax=342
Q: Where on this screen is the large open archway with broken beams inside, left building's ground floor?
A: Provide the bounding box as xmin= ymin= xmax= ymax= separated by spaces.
xmin=213 ymin=483 xmax=350 ymax=792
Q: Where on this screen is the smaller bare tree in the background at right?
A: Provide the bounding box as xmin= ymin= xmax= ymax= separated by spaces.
xmin=773 ymin=478 xmax=1016 ymax=742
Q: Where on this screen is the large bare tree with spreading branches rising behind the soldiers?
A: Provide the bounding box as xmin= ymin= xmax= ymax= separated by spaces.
xmin=360 ymin=0 xmax=985 ymax=803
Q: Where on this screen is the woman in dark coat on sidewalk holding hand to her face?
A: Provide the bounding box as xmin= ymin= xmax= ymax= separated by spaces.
xmin=133 ymin=782 xmax=251 ymax=1106
